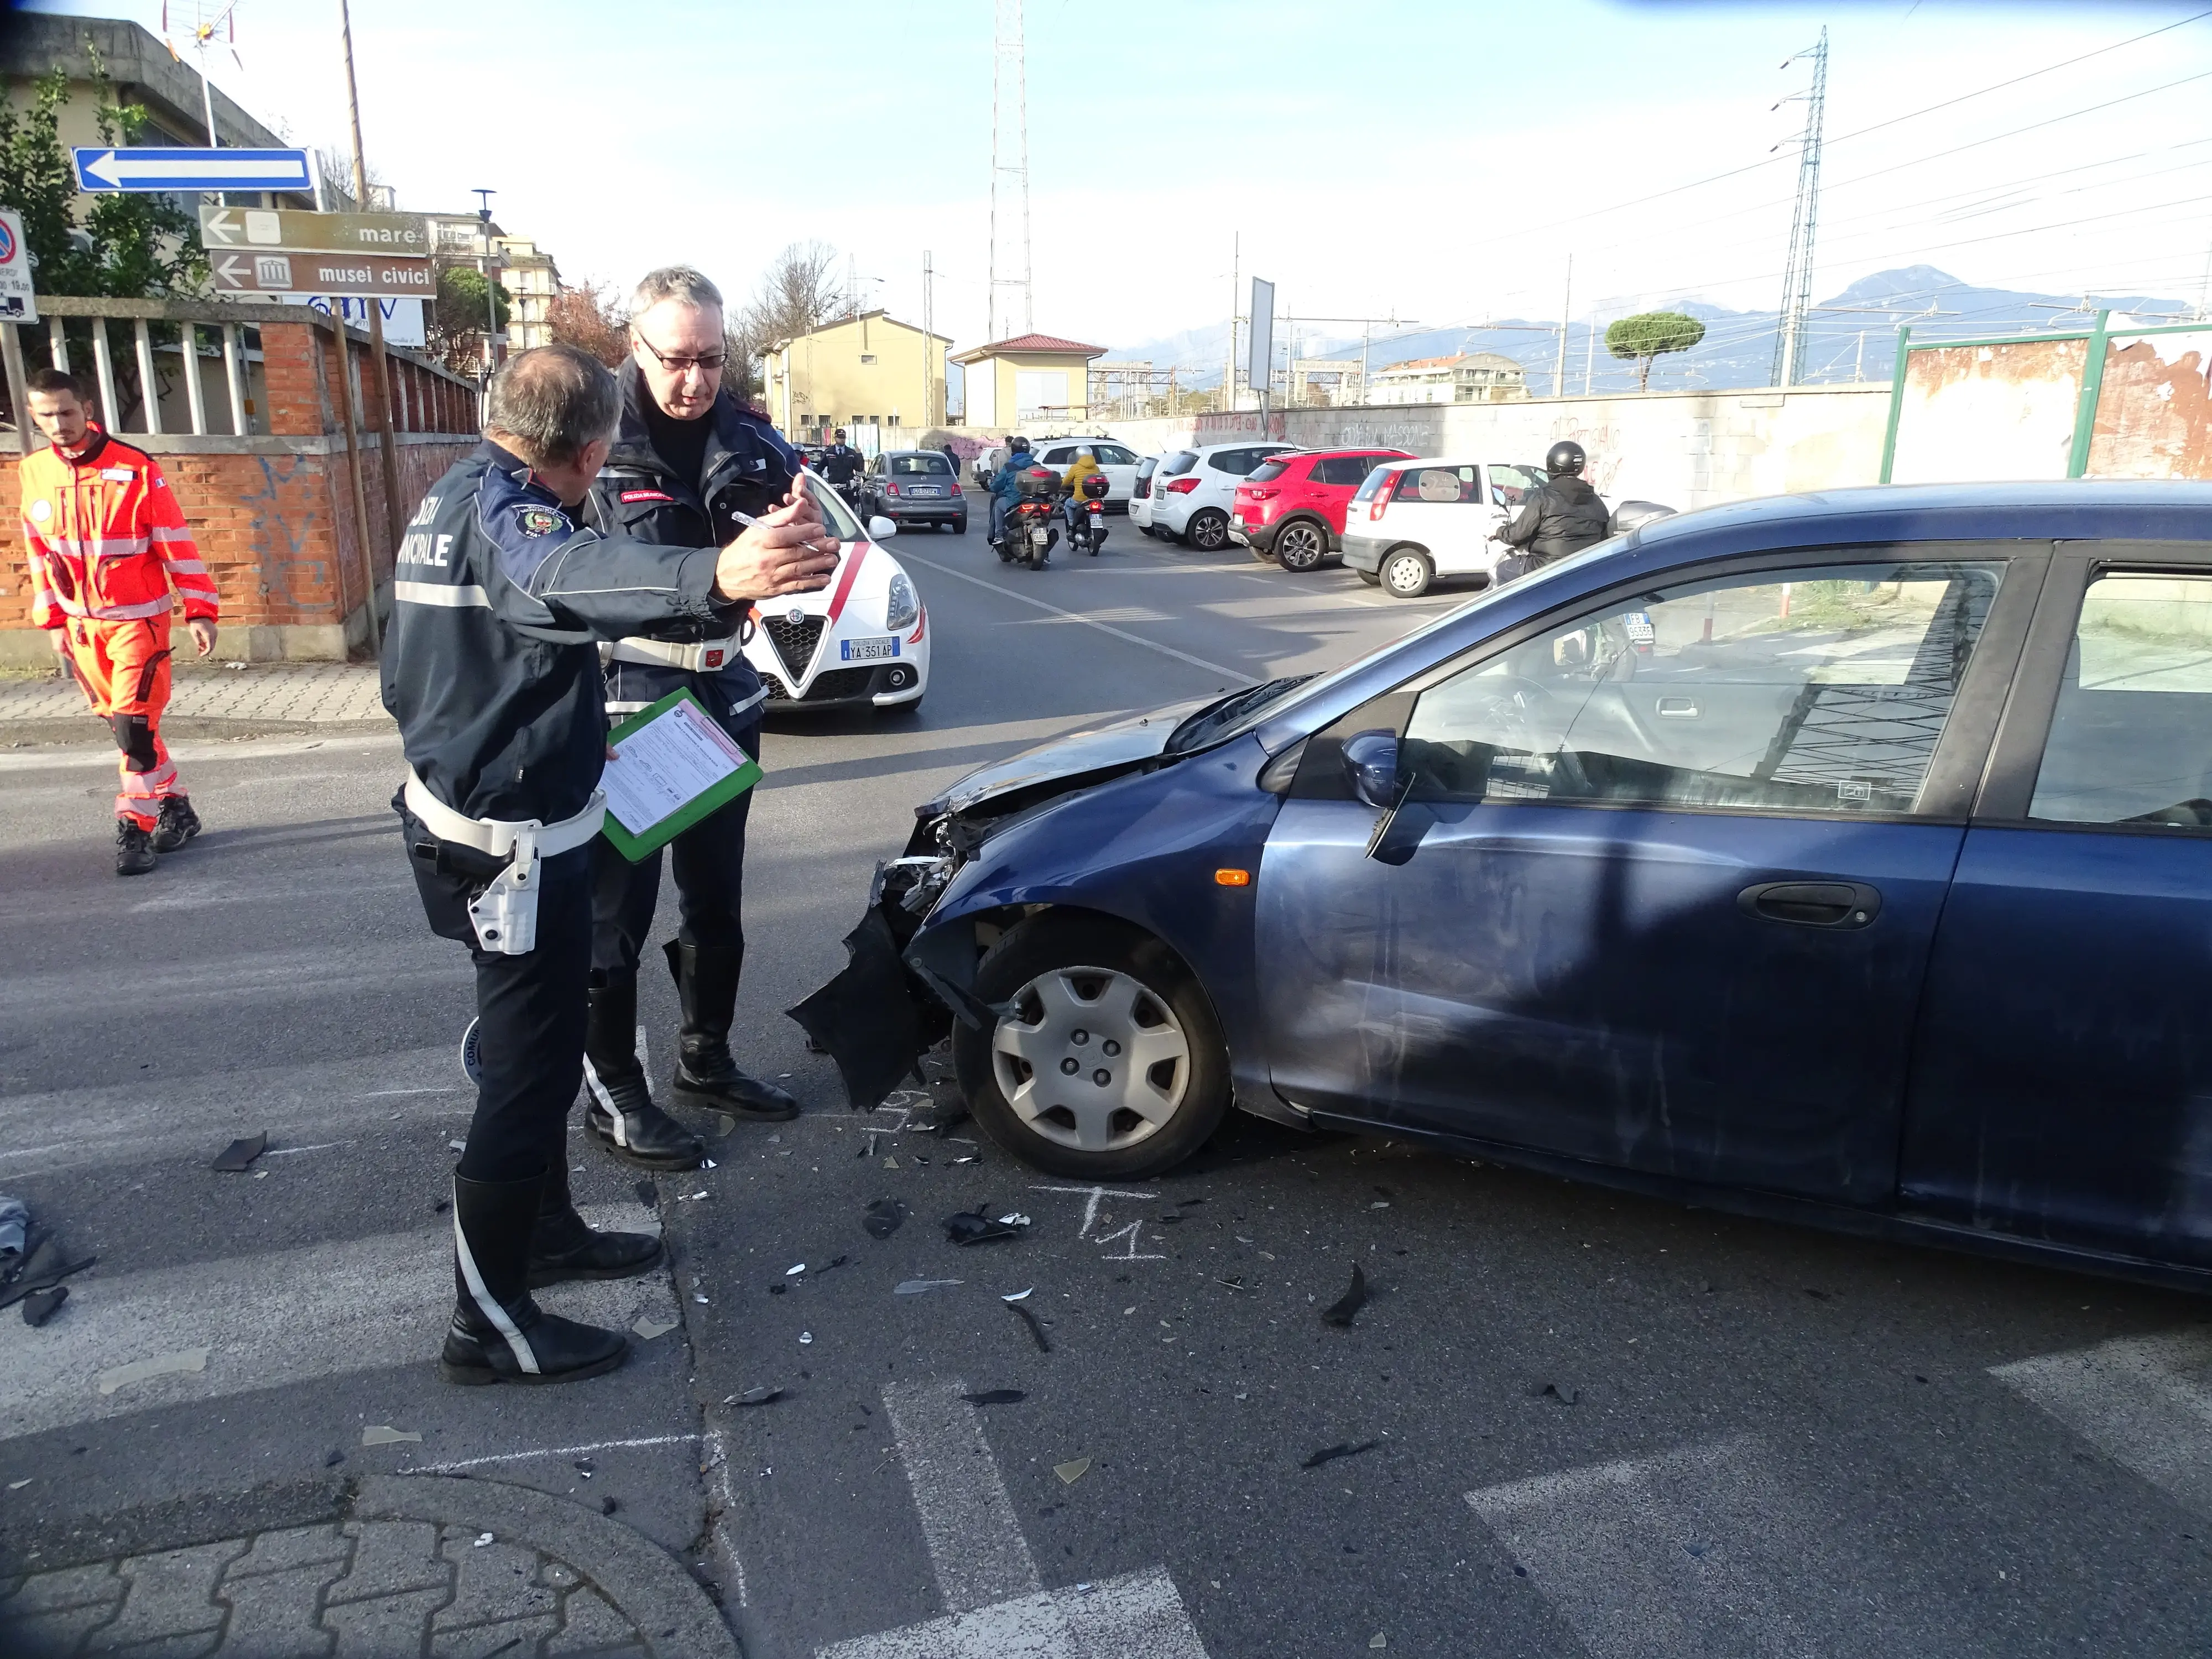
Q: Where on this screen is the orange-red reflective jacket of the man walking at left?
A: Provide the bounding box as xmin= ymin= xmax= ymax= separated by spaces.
xmin=22 ymin=427 xmax=217 ymax=628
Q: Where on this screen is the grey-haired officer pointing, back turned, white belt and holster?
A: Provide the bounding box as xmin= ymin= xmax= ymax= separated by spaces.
xmin=383 ymin=345 xmax=836 ymax=1383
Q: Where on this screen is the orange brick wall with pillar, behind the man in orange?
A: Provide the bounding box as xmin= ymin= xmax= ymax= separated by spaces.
xmin=0 ymin=325 xmax=476 ymax=664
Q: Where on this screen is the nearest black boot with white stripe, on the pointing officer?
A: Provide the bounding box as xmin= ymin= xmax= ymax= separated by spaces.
xmin=438 ymin=1175 xmax=630 ymax=1385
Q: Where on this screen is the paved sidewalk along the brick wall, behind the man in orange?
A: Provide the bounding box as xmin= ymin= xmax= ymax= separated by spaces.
xmin=0 ymin=661 xmax=392 ymax=743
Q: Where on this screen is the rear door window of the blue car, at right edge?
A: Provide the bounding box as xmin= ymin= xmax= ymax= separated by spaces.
xmin=2028 ymin=571 xmax=2212 ymax=830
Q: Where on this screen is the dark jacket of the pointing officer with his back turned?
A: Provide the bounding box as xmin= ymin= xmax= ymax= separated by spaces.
xmin=383 ymin=442 xmax=730 ymax=823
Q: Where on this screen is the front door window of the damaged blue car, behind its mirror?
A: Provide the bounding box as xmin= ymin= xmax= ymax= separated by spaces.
xmin=1405 ymin=562 xmax=2004 ymax=814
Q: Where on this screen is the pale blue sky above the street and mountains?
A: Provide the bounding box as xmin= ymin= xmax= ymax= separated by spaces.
xmin=30 ymin=0 xmax=2212 ymax=365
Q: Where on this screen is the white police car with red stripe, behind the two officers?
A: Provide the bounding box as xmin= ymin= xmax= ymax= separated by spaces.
xmin=745 ymin=473 xmax=929 ymax=710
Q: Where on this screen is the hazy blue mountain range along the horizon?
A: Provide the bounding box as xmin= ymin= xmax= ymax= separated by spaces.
xmin=1097 ymin=265 xmax=2192 ymax=396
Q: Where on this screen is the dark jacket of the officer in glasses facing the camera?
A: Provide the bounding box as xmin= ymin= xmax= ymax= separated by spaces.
xmin=584 ymin=374 xmax=801 ymax=737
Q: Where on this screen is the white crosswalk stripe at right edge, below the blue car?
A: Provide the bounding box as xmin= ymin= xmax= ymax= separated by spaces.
xmin=1991 ymin=1329 xmax=2212 ymax=1513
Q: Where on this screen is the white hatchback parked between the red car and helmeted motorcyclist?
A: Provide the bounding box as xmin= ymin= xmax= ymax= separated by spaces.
xmin=1345 ymin=458 xmax=1546 ymax=599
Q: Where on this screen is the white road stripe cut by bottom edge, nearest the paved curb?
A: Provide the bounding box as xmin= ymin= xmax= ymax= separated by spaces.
xmin=816 ymin=1566 xmax=1206 ymax=1659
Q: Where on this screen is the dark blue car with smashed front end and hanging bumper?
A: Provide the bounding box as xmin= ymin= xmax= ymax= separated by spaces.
xmin=801 ymin=482 xmax=2212 ymax=1287
